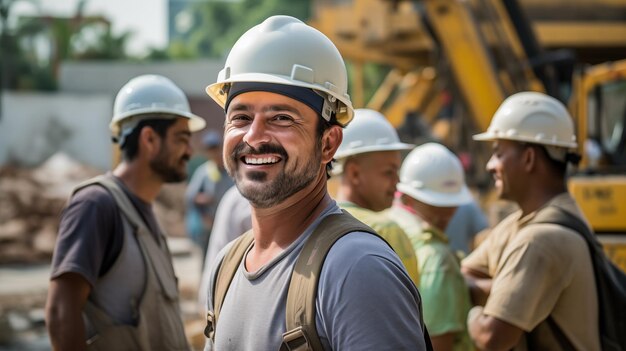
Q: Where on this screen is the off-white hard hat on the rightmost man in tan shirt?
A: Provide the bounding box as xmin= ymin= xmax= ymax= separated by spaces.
xmin=474 ymin=92 xmax=577 ymax=161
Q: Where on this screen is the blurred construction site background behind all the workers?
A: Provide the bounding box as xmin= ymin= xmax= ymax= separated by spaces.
xmin=0 ymin=0 xmax=626 ymax=350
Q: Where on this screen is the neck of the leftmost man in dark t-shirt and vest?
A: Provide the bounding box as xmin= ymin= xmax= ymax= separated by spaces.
xmin=113 ymin=162 xmax=163 ymax=204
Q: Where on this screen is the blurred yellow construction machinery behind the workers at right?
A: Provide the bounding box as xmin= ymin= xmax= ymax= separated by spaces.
xmin=311 ymin=0 xmax=626 ymax=271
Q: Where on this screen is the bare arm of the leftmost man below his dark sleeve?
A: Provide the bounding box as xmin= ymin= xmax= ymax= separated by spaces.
xmin=46 ymin=273 xmax=91 ymax=350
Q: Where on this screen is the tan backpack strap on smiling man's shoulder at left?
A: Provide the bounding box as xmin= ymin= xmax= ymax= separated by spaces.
xmin=204 ymin=230 xmax=254 ymax=341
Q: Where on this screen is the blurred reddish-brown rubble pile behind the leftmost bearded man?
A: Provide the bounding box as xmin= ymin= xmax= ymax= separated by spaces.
xmin=0 ymin=153 xmax=185 ymax=264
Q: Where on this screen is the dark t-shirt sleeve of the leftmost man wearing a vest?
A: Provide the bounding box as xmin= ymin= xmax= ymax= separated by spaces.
xmin=51 ymin=185 xmax=123 ymax=287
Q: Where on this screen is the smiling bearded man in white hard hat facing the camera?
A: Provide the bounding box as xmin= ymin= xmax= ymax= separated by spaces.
xmin=205 ymin=16 xmax=425 ymax=350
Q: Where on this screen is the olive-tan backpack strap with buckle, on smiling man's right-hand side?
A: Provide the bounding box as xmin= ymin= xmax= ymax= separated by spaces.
xmin=280 ymin=211 xmax=384 ymax=351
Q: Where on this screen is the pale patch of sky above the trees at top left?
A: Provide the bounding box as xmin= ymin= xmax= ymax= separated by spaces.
xmin=11 ymin=0 xmax=167 ymax=55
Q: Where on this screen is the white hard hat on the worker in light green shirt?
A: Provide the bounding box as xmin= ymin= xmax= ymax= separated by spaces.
xmin=397 ymin=143 xmax=472 ymax=207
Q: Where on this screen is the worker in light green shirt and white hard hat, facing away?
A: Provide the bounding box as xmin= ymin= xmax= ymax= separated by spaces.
xmin=387 ymin=143 xmax=472 ymax=351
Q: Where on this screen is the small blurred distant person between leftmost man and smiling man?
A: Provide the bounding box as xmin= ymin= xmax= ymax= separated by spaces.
xmin=185 ymin=130 xmax=234 ymax=266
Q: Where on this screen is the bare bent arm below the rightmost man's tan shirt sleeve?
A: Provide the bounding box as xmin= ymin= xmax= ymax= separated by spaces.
xmin=467 ymin=306 xmax=524 ymax=350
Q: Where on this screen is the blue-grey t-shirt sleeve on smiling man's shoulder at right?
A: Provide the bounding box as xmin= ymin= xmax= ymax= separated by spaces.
xmin=316 ymin=232 xmax=425 ymax=350
